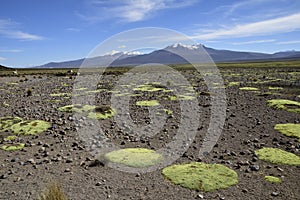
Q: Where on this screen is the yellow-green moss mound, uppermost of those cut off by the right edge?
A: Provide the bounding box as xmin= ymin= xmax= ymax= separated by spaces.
xmin=268 ymin=99 xmax=300 ymax=113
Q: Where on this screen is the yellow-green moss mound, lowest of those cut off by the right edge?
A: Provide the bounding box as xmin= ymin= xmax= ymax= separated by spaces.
xmin=255 ymin=147 xmax=300 ymax=165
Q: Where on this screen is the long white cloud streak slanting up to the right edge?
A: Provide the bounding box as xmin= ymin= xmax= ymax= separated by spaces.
xmin=192 ymin=13 xmax=300 ymax=40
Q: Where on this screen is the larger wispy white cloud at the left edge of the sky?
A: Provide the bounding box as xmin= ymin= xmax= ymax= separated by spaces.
xmin=0 ymin=19 xmax=44 ymax=40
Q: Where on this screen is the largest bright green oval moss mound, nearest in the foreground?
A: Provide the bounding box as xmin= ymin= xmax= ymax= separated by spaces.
xmin=162 ymin=162 xmax=238 ymax=192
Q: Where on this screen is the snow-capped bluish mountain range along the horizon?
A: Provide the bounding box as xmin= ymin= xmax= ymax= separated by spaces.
xmin=34 ymin=44 xmax=300 ymax=68
